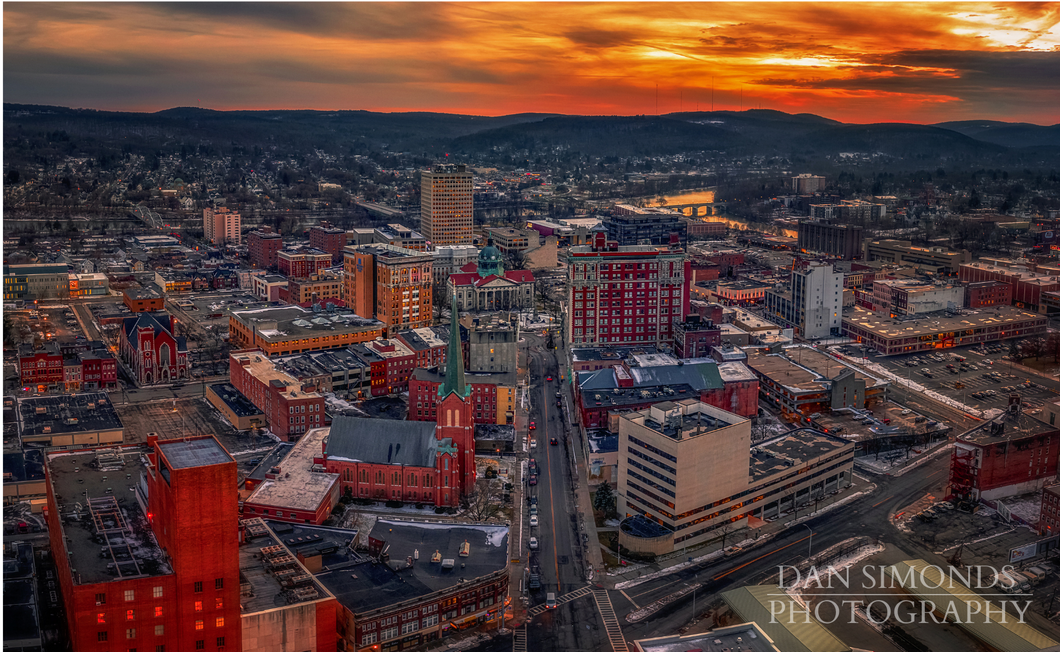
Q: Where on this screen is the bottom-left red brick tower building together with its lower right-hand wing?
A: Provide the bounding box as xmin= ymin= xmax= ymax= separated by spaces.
xmin=45 ymin=434 xmax=336 ymax=652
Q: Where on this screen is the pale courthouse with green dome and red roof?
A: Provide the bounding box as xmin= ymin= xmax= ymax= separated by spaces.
xmin=446 ymin=239 xmax=534 ymax=313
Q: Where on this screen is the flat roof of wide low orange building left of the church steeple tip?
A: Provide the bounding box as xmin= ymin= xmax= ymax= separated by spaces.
xmin=231 ymin=305 xmax=383 ymax=341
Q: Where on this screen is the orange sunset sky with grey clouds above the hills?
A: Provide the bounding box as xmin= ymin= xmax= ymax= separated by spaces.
xmin=3 ymin=2 xmax=1060 ymax=124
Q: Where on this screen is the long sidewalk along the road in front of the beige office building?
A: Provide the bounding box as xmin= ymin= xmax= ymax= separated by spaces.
xmin=594 ymin=475 xmax=876 ymax=589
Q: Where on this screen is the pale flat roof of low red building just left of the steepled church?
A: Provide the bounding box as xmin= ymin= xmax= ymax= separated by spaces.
xmin=244 ymin=428 xmax=338 ymax=512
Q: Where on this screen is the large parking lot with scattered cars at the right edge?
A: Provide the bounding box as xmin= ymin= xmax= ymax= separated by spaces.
xmin=873 ymin=343 xmax=1060 ymax=415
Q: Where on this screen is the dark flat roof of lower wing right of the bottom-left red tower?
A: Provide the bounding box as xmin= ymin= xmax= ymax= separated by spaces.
xmin=240 ymin=518 xmax=330 ymax=615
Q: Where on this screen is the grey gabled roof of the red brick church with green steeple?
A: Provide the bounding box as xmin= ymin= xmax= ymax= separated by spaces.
xmin=324 ymin=415 xmax=438 ymax=469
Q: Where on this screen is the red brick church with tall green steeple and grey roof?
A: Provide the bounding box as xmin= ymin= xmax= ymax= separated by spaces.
xmin=323 ymin=298 xmax=475 ymax=507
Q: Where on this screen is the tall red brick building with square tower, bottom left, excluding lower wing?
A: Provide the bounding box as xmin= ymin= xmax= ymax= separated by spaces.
xmin=46 ymin=436 xmax=242 ymax=652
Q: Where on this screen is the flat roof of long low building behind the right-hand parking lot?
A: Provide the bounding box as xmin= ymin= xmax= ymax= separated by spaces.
xmin=843 ymin=305 xmax=1045 ymax=338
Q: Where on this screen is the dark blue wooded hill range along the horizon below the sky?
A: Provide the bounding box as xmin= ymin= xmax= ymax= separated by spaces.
xmin=3 ymin=104 xmax=1060 ymax=168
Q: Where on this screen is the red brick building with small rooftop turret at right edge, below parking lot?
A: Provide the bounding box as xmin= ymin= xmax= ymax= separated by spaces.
xmin=950 ymin=394 xmax=1060 ymax=500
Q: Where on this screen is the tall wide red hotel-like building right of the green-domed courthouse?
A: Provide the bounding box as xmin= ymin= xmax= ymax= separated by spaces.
xmin=566 ymin=232 xmax=692 ymax=347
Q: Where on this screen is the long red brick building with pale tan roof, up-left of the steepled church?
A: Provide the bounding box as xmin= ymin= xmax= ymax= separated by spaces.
xmin=229 ymin=350 xmax=325 ymax=441
